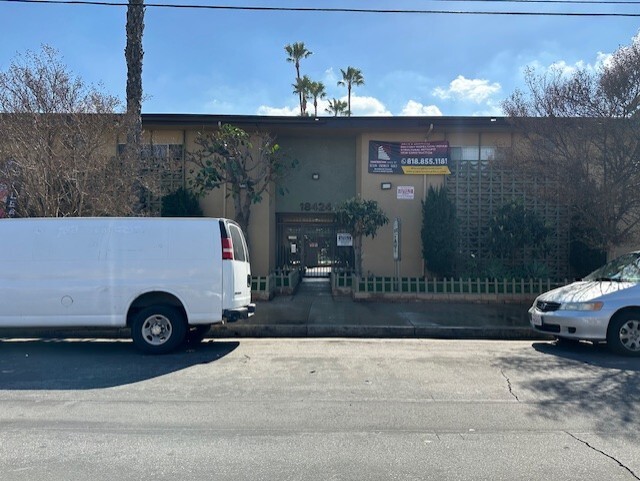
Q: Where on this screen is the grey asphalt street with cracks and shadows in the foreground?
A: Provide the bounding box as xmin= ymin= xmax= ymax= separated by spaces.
xmin=0 ymin=339 xmax=640 ymax=481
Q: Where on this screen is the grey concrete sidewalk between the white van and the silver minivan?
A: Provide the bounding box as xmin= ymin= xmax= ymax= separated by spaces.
xmin=211 ymin=279 xmax=544 ymax=339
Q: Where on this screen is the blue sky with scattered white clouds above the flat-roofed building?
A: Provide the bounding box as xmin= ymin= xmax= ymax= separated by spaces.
xmin=0 ymin=0 xmax=640 ymax=116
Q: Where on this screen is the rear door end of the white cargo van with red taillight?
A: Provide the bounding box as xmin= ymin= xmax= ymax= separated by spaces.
xmin=220 ymin=220 xmax=254 ymax=318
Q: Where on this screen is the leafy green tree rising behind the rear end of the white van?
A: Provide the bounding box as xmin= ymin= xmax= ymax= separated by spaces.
xmin=187 ymin=124 xmax=297 ymax=244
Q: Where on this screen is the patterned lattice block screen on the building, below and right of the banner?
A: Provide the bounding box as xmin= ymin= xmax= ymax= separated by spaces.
xmin=445 ymin=147 xmax=569 ymax=279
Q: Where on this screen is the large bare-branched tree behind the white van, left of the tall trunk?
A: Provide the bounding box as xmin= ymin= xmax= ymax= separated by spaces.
xmin=0 ymin=46 xmax=156 ymax=217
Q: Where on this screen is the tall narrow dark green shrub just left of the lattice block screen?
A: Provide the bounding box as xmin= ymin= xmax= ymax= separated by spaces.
xmin=421 ymin=187 xmax=457 ymax=277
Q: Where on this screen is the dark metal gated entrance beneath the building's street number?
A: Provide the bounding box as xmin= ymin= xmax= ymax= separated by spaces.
xmin=277 ymin=214 xmax=353 ymax=277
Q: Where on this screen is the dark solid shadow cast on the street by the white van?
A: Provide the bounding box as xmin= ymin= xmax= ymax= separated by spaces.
xmin=0 ymin=339 xmax=240 ymax=392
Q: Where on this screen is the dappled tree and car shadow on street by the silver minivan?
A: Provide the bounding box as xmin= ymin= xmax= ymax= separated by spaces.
xmin=496 ymin=341 xmax=640 ymax=436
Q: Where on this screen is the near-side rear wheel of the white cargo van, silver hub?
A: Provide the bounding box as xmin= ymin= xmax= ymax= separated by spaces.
xmin=131 ymin=305 xmax=187 ymax=354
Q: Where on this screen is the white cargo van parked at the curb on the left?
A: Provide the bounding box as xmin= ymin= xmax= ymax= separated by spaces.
xmin=0 ymin=217 xmax=255 ymax=353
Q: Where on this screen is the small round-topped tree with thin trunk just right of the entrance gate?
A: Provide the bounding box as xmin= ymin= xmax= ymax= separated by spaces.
xmin=336 ymin=197 xmax=389 ymax=275
